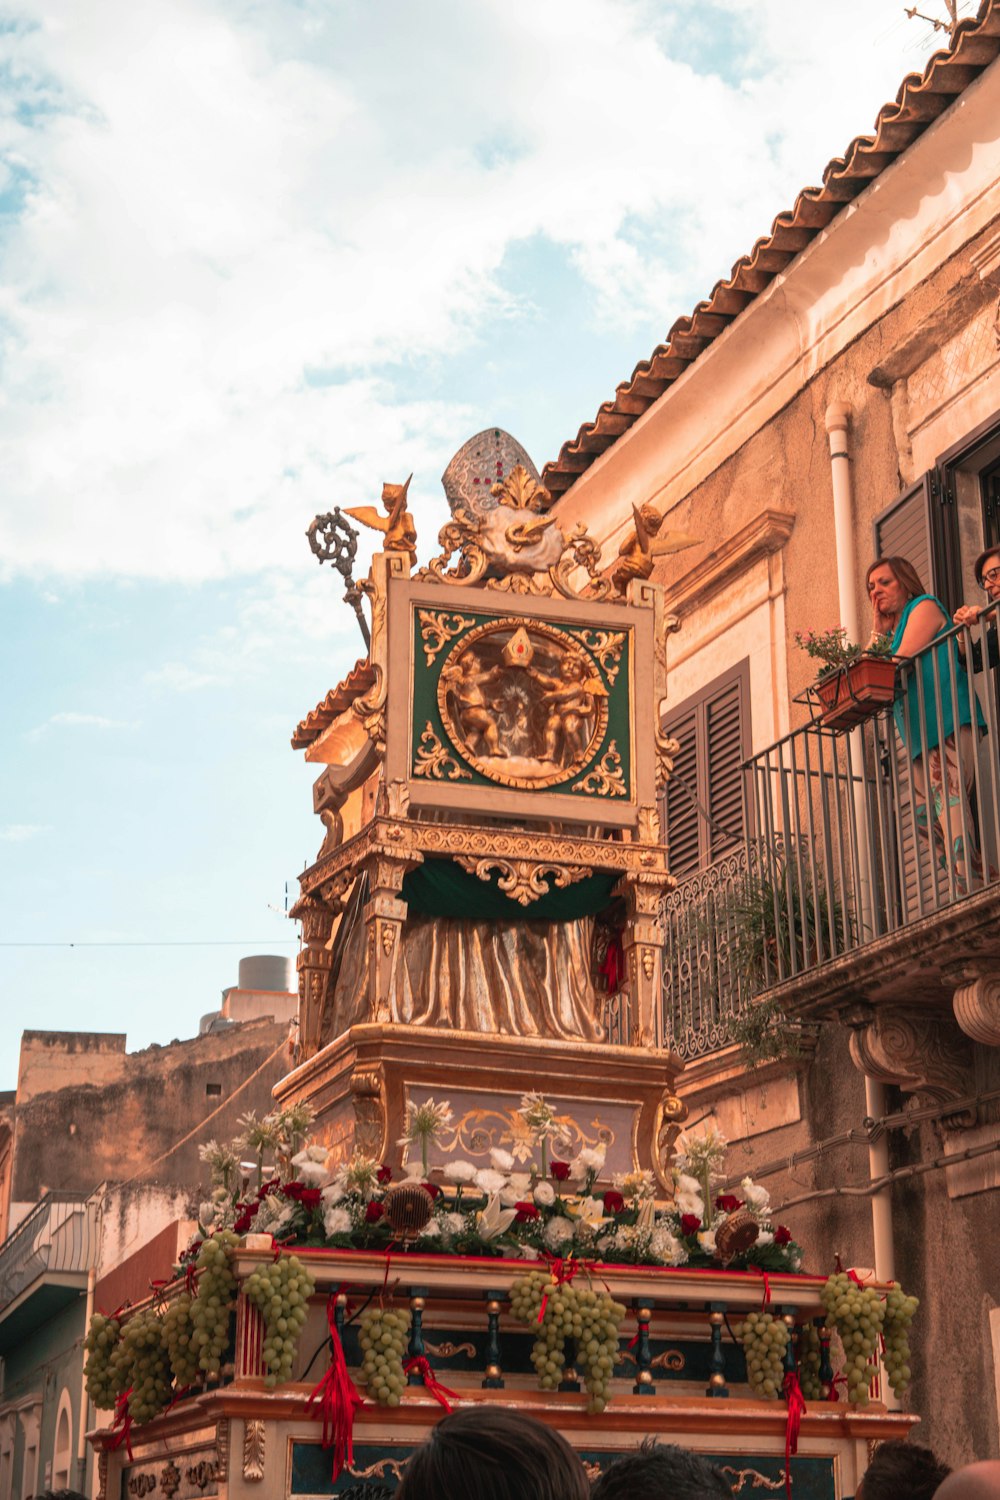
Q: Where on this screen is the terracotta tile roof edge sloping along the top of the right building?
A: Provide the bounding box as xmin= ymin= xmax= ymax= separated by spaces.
xmin=542 ymin=0 xmax=1000 ymax=501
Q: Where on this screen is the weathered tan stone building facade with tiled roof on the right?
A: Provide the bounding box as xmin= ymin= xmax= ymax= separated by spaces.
xmin=543 ymin=3 xmax=1000 ymax=1463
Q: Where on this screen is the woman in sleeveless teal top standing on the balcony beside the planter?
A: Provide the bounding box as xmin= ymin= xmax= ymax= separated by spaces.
xmin=867 ymin=557 xmax=985 ymax=891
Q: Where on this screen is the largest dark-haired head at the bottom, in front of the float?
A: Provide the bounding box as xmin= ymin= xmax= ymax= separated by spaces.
xmin=396 ymin=1406 xmax=591 ymax=1500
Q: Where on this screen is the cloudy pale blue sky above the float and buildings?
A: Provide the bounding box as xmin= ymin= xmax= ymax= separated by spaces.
xmin=0 ymin=0 xmax=973 ymax=1091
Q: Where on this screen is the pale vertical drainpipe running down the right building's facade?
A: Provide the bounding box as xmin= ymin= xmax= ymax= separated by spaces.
xmin=826 ymin=401 xmax=895 ymax=1281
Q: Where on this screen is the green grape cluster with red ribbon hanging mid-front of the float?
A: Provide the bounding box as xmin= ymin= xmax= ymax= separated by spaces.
xmin=510 ymin=1271 xmax=625 ymax=1413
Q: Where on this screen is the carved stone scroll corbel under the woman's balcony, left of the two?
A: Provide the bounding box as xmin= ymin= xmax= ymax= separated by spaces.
xmin=850 ymin=1007 xmax=973 ymax=1124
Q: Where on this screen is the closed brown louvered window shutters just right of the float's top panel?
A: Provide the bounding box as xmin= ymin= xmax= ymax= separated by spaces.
xmin=663 ymin=662 xmax=750 ymax=875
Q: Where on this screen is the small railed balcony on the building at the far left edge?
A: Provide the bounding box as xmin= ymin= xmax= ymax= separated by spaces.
xmin=0 ymin=1193 xmax=97 ymax=1355
